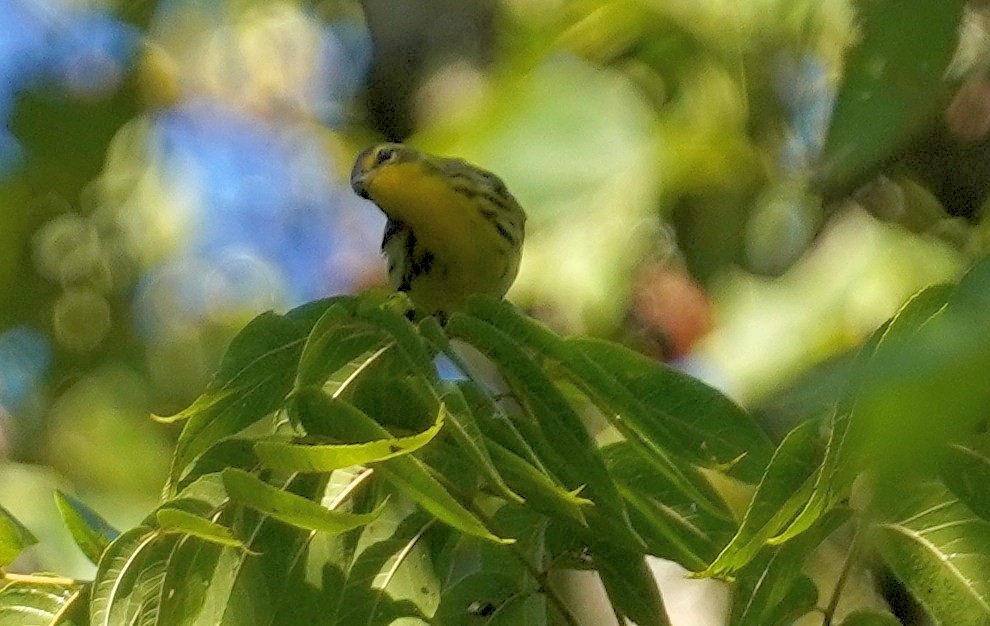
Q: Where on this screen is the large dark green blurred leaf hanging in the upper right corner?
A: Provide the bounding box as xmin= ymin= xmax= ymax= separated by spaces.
xmin=816 ymin=0 xmax=966 ymax=198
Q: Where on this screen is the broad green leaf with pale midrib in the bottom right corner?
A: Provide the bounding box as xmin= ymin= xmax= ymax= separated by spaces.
xmin=876 ymin=482 xmax=990 ymax=624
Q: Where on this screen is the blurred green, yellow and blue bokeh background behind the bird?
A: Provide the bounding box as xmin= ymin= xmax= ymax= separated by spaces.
xmin=0 ymin=0 xmax=990 ymax=575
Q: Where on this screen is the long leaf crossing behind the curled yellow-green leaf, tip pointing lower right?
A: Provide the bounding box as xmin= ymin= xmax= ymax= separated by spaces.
xmin=292 ymin=389 xmax=511 ymax=542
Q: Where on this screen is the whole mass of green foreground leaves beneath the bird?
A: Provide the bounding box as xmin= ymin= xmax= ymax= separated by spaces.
xmin=0 ymin=251 xmax=990 ymax=625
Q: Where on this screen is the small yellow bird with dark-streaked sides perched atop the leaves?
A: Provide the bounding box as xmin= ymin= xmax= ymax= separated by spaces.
xmin=350 ymin=143 xmax=526 ymax=316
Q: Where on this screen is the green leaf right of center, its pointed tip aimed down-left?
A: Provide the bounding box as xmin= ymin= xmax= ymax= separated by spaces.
xmin=699 ymin=420 xmax=821 ymax=577
